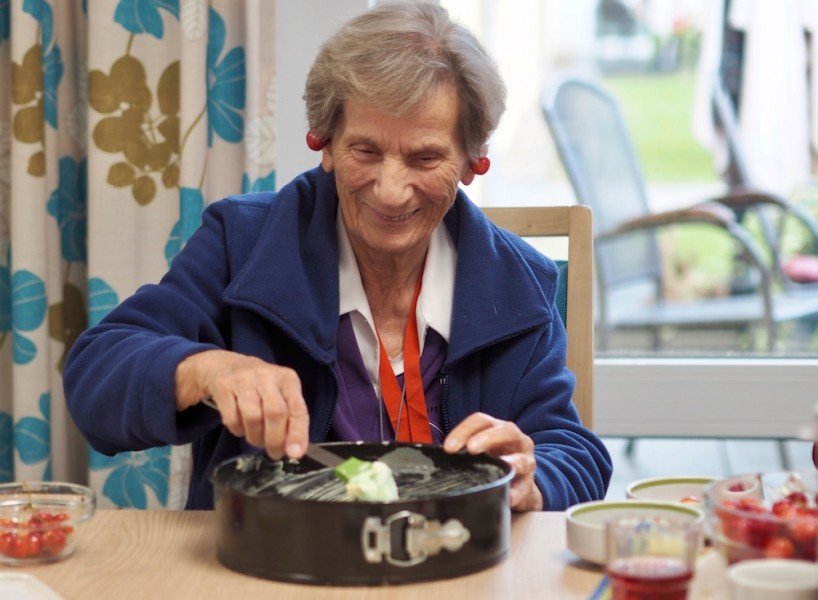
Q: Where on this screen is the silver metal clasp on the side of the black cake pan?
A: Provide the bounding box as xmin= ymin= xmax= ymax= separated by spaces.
xmin=361 ymin=510 xmax=471 ymax=567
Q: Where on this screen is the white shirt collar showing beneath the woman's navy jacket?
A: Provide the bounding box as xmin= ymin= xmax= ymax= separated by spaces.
xmin=335 ymin=208 xmax=457 ymax=393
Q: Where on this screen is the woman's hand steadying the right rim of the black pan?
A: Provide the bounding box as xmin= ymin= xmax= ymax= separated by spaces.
xmin=443 ymin=412 xmax=543 ymax=511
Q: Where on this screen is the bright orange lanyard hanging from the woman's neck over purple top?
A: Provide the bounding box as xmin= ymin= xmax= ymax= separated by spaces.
xmin=378 ymin=269 xmax=432 ymax=444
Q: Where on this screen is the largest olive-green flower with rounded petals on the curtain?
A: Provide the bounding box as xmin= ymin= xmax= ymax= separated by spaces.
xmin=88 ymin=55 xmax=179 ymax=205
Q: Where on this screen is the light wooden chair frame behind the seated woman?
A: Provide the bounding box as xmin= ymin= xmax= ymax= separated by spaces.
xmin=483 ymin=205 xmax=594 ymax=428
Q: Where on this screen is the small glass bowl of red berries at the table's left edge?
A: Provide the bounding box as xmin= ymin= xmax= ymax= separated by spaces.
xmin=0 ymin=481 xmax=96 ymax=565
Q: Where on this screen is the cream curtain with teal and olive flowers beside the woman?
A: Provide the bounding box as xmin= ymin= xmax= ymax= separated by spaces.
xmin=0 ymin=0 xmax=276 ymax=508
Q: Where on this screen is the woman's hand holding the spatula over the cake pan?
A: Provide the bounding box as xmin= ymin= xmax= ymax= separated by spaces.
xmin=176 ymin=350 xmax=310 ymax=459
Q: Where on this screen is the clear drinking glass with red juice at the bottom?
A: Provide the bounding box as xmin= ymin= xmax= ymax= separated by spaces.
xmin=605 ymin=516 xmax=702 ymax=600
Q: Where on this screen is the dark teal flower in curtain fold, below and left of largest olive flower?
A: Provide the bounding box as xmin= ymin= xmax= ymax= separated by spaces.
xmin=47 ymin=156 xmax=88 ymax=263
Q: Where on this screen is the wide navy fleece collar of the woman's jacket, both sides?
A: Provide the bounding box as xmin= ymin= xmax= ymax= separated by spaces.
xmin=225 ymin=167 xmax=552 ymax=364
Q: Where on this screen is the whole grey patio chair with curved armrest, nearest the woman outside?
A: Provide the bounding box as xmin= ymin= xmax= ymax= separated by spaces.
xmin=542 ymin=78 xmax=818 ymax=350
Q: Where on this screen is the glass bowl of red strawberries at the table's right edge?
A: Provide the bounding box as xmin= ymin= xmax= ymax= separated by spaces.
xmin=705 ymin=471 xmax=818 ymax=564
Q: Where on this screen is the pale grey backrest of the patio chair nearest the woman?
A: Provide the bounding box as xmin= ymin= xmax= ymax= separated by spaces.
xmin=542 ymin=78 xmax=662 ymax=298
